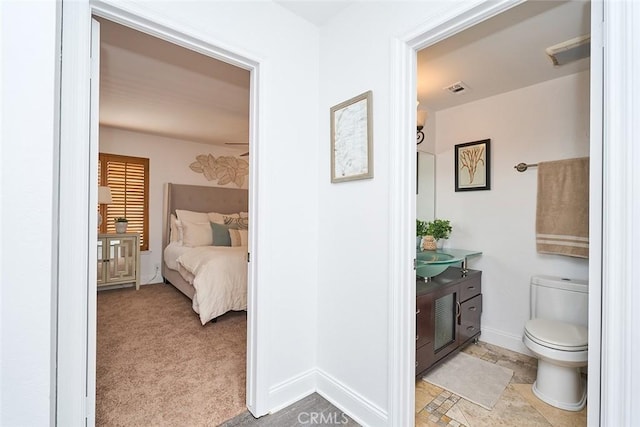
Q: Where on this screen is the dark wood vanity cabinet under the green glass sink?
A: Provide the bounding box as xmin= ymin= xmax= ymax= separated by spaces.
xmin=416 ymin=267 xmax=482 ymax=376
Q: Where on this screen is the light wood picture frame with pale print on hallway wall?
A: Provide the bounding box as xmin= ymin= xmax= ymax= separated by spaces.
xmin=330 ymin=91 xmax=373 ymax=183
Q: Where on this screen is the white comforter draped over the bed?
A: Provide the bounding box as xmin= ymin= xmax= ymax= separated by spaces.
xmin=177 ymin=246 xmax=247 ymax=325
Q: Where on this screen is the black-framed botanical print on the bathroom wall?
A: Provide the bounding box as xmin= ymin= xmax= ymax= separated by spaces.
xmin=454 ymin=139 xmax=491 ymax=191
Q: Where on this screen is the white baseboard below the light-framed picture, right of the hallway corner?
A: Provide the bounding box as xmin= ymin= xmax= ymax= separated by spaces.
xmin=316 ymin=369 xmax=389 ymax=426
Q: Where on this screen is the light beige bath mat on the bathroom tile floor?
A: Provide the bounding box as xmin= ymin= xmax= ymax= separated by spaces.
xmin=422 ymin=353 xmax=513 ymax=410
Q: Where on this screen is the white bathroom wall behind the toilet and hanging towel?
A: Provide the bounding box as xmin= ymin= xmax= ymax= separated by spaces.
xmin=436 ymin=71 xmax=589 ymax=352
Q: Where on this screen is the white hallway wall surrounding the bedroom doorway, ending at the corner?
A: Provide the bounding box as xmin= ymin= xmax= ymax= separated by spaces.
xmin=1 ymin=1 xmax=319 ymax=425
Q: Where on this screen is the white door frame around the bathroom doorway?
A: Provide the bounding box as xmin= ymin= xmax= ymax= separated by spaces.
xmin=388 ymin=0 xmax=604 ymax=426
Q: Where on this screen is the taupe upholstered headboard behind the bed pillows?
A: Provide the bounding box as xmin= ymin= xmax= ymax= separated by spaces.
xmin=162 ymin=183 xmax=249 ymax=251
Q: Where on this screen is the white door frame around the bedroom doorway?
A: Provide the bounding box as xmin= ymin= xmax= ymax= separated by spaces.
xmin=54 ymin=0 xmax=268 ymax=425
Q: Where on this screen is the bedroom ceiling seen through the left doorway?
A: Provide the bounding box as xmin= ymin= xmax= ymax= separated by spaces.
xmin=100 ymin=20 xmax=250 ymax=151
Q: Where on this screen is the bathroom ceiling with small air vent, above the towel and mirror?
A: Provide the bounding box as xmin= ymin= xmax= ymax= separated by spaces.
xmin=418 ymin=0 xmax=590 ymax=111
